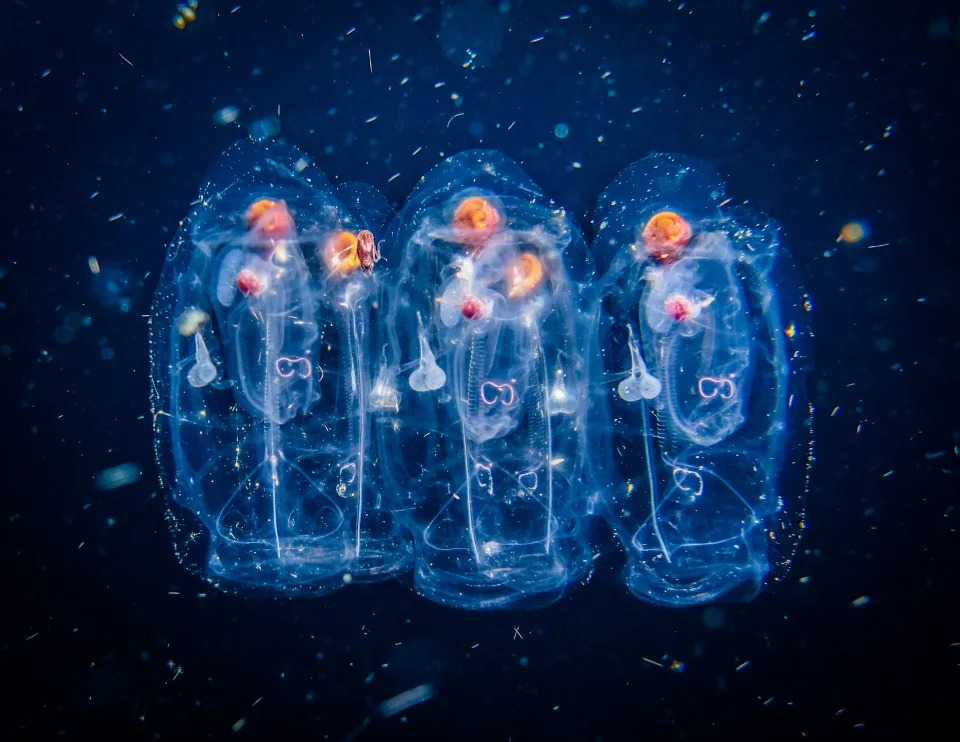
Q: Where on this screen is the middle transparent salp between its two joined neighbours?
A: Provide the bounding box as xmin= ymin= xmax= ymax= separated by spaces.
xmin=375 ymin=151 xmax=592 ymax=608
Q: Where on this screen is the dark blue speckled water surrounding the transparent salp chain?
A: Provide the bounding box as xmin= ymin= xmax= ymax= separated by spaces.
xmin=0 ymin=0 xmax=960 ymax=741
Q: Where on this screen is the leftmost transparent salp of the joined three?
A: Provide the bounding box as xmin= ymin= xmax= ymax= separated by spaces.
xmin=151 ymin=141 xmax=410 ymax=592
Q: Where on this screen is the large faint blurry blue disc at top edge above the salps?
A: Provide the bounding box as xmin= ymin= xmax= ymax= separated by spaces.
xmin=438 ymin=0 xmax=507 ymax=69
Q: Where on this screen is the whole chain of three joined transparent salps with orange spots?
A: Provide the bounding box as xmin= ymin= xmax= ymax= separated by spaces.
xmin=151 ymin=142 xmax=812 ymax=609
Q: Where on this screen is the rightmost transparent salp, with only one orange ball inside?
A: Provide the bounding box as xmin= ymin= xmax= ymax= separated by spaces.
xmin=588 ymin=155 xmax=812 ymax=605
